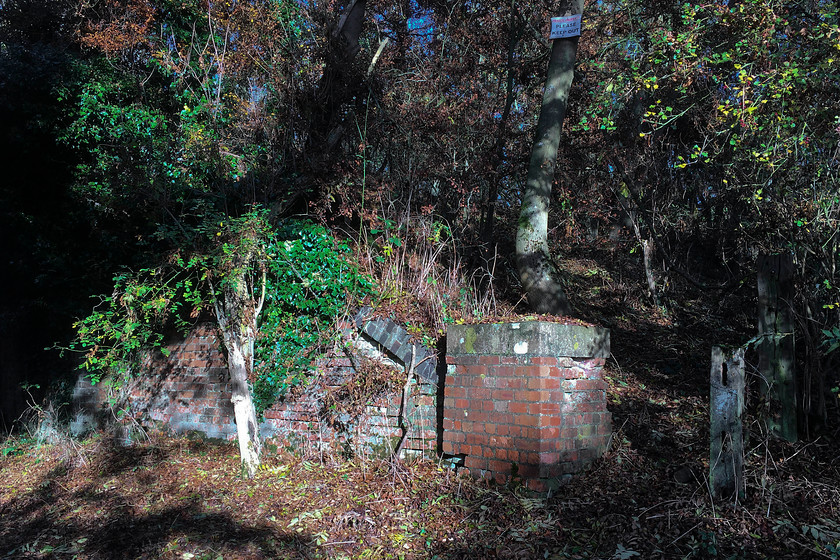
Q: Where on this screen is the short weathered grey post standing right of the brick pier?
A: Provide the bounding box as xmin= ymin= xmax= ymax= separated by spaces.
xmin=709 ymin=346 xmax=745 ymax=500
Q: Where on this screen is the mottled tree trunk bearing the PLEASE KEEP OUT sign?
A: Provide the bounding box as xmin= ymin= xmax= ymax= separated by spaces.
xmin=516 ymin=0 xmax=583 ymax=315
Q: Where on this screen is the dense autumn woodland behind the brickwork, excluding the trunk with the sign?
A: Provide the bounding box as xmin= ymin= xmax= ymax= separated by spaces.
xmin=0 ymin=0 xmax=840 ymax=557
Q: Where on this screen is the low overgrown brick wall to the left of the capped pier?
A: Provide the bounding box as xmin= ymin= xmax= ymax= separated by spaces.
xmin=74 ymin=324 xmax=437 ymax=456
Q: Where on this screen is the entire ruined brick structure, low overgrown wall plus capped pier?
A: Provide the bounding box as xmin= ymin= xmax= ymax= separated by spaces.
xmin=74 ymin=319 xmax=611 ymax=491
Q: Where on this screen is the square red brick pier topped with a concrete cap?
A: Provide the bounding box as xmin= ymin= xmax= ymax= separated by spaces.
xmin=443 ymin=321 xmax=611 ymax=491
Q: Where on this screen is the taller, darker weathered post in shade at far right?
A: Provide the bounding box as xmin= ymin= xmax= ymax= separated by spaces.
xmin=758 ymin=254 xmax=797 ymax=441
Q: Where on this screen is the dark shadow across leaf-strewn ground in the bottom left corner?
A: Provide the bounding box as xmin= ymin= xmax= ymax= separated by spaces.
xmin=0 ymin=445 xmax=312 ymax=560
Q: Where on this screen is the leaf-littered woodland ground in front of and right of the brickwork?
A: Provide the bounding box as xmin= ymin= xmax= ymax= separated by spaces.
xmin=0 ymin=247 xmax=840 ymax=560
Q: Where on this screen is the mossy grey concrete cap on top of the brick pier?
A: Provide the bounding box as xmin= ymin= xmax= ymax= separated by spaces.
xmin=446 ymin=320 xmax=610 ymax=359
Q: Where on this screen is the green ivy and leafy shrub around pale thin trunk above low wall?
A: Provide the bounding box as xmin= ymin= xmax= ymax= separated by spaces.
xmin=70 ymin=211 xmax=372 ymax=412
